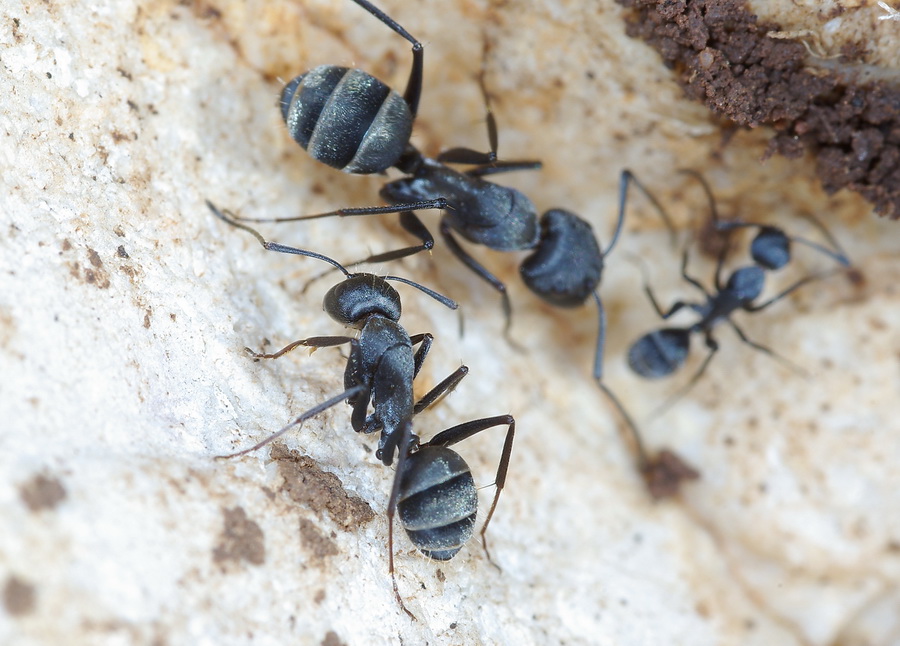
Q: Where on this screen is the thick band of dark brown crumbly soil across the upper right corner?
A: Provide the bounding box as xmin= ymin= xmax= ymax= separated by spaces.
xmin=616 ymin=0 xmax=900 ymax=220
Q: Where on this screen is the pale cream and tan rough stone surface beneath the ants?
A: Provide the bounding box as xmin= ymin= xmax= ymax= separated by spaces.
xmin=0 ymin=0 xmax=900 ymax=646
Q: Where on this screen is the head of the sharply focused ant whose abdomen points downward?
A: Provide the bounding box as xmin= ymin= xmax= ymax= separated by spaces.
xmin=323 ymin=274 xmax=401 ymax=328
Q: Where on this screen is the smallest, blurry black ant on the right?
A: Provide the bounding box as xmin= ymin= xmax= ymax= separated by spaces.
xmin=628 ymin=171 xmax=850 ymax=412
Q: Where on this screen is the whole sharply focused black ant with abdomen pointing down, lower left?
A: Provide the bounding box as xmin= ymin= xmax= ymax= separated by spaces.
xmin=207 ymin=201 xmax=516 ymax=619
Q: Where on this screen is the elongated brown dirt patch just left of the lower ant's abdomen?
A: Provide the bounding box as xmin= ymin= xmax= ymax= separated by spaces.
xmin=272 ymin=444 xmax=375 ymax=531
